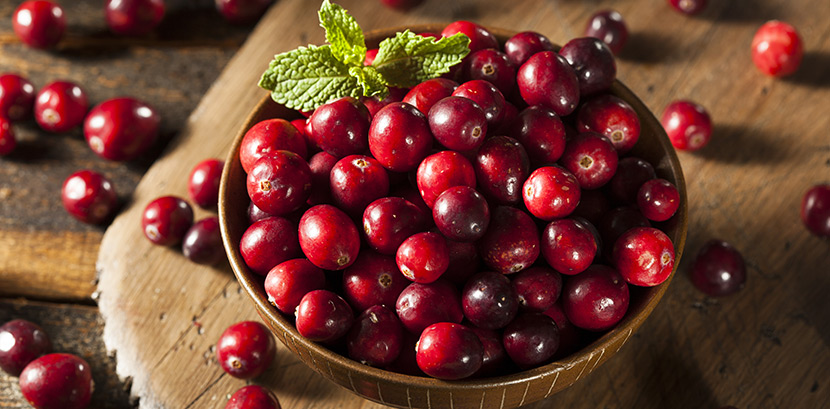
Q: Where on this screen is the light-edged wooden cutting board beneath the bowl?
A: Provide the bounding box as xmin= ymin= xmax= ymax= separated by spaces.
xmin=97 ymin=0 xmax=830 ymax=409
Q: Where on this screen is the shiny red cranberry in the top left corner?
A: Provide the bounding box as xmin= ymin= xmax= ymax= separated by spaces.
xmin=12 ymin=0 xmax=66 ymax=49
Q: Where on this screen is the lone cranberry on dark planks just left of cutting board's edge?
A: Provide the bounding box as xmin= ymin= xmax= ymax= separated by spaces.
xmin=61 ymin=170 xmax=118 ymax=224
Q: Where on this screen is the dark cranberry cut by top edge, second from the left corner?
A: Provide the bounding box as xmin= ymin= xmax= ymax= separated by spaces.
xmin=106 ymin=0 xmax=164 ymax=36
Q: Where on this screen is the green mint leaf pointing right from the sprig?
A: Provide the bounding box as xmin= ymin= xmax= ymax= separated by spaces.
xmin=372 ymin=30 xmax=470 ymax=87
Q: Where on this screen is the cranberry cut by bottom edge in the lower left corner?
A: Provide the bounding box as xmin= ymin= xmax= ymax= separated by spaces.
xmin=19 ymin=354 xmax=94 ymax=409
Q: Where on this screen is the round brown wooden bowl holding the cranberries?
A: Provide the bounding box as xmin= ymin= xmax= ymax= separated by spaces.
xmin=219 ymin=25 xmax=688 ymax=409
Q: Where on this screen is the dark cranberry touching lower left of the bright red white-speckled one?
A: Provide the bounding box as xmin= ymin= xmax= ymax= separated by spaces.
xmin=478 ymin=206 xmax=540 ymax=274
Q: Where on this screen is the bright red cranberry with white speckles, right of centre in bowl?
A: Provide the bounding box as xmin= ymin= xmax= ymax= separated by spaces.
xmin=522 ymin=166 xmax=581 ymax=221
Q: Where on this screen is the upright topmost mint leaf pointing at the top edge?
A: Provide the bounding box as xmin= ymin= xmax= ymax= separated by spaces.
xmin=317 ymin=0 xmax=366 ymax=66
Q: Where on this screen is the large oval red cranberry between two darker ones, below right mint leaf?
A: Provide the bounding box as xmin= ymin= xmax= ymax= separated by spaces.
xmin=370 ymin=102 xmax=432 ymax=172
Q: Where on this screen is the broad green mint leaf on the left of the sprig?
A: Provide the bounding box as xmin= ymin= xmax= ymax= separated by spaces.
xmin=259 ymin=45 xmax=369 ymax=111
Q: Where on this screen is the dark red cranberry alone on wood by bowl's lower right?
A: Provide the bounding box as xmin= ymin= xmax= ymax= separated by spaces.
xmin=689 ymin=240 xmax=746 ymax=297
